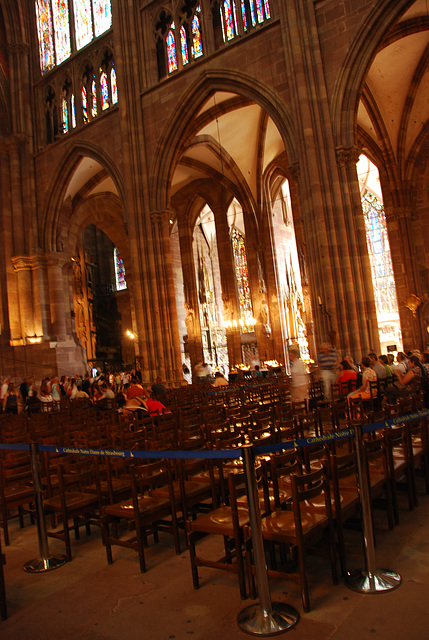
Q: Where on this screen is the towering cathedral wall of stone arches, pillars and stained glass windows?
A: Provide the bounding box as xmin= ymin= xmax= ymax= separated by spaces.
xmin=0 ymin=0 xmax=429 ymax=385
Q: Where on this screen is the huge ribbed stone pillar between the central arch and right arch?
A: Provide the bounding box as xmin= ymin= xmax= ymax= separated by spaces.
xmin=279 ymin=0 xmax=379 ymax=357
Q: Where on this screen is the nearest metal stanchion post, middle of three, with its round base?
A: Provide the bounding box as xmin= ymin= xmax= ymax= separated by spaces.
xmin=237 ymin=445 xmax=299 ymax=636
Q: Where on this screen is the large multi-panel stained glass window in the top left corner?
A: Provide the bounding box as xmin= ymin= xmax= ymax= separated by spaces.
xmin=35 ymin=0 xmax=112 ymax=73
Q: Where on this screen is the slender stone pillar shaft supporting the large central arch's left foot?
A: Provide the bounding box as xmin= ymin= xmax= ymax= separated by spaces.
xmin=150 ymin=210 xmax=183 ymax=381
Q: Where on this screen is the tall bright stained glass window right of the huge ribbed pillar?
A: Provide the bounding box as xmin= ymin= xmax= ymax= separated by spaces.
xmin=362 ymin=191 xmax=398 ymax=315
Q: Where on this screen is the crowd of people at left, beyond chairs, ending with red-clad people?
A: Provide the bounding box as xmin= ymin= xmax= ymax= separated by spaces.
xmin=0 ymin=370 xmax=170 ymax=414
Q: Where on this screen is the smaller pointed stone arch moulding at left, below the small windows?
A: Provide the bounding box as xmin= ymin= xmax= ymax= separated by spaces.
xmin=43 ymin=142 xmax=126 ymax=251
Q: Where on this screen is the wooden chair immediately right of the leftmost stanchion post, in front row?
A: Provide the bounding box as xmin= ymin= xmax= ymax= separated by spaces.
xmin=43 ymin=459 xmax=101 ymax=561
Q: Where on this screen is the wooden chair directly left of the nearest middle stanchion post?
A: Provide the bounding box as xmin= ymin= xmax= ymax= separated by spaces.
xmin=186 ymin=472 xmax=249 ymax=599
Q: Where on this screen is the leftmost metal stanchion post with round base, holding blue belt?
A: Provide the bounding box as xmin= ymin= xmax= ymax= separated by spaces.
xmin=24 ymin=442 xmax=67 ymax=573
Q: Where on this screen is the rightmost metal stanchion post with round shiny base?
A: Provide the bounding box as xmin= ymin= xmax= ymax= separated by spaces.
xmin=345 ymin=425 xmax=402 ymax=593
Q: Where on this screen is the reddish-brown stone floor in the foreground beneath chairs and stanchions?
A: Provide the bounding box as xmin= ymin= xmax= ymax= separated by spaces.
xmin=0 ymin=486 xmax=429 ymax=640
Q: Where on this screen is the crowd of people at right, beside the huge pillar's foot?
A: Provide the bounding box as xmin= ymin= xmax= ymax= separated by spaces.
xmin=289 ymin=343 xmax=429 ymax=406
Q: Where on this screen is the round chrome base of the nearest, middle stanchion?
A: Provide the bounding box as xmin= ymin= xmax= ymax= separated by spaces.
xmin=237 ymin=602 xmax=299 ymax=636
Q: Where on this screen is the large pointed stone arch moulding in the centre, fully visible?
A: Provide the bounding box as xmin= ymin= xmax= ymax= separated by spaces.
xmin=151 ymin=70 xmax=297 ymax=210
